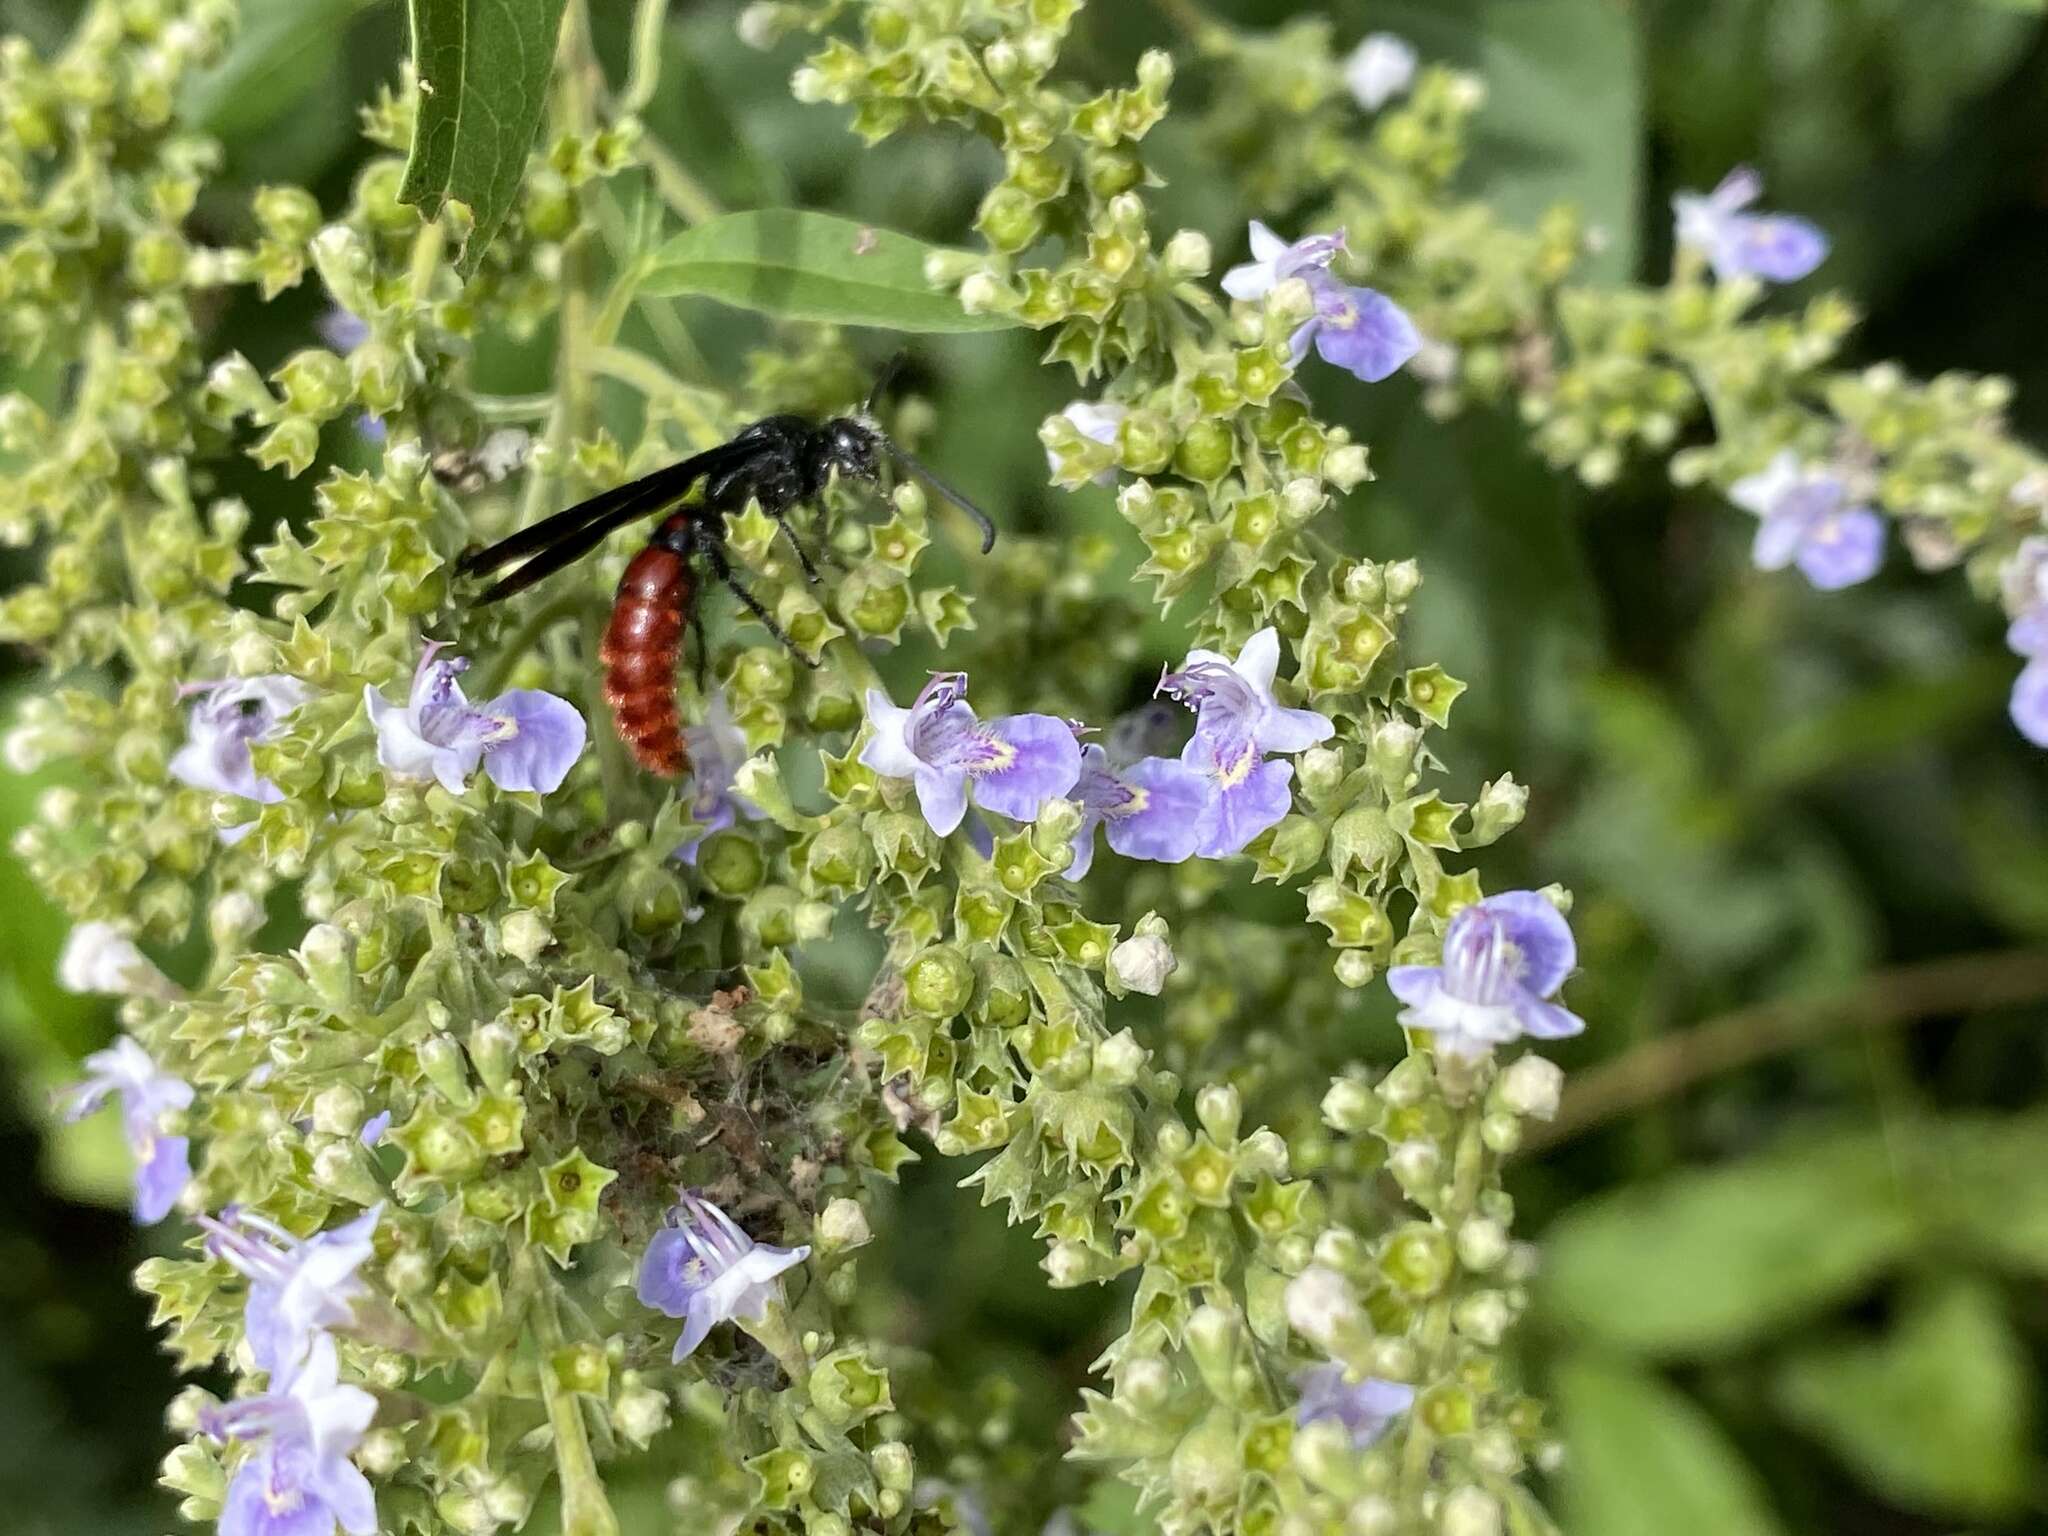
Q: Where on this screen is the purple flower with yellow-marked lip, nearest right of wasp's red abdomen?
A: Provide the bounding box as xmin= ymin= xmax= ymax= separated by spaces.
xmin=860 ymin=672 xmax=1081 ymax=838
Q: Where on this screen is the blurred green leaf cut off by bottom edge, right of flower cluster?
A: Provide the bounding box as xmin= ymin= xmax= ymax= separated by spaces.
xmin=1552 ymin=1356 xmax=1780 ymax=1536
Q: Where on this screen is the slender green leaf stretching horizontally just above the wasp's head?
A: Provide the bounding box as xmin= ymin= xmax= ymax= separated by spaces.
xmin=641 ymin=209 xmax=1016 ymax=334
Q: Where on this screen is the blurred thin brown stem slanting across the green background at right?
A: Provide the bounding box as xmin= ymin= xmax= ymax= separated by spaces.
xmin=1524 ymin=948 xmax=2048 ymax=1151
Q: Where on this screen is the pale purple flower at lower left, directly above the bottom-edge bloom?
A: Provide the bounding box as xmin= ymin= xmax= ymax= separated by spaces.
xmin=199 ymin=1206 xmax=383 ymax=1380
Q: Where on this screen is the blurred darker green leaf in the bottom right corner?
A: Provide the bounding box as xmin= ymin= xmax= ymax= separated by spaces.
xmin=1778 ymin=1280 xmax=2032 ymax=1522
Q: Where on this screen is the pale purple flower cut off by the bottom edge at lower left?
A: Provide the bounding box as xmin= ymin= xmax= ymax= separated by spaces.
xmin=201 ymin=1333 xmax=377 ymax=1536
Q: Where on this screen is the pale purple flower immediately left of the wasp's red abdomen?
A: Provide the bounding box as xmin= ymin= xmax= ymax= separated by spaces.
xmin=362 ymin=641 xmax=586 ymax=795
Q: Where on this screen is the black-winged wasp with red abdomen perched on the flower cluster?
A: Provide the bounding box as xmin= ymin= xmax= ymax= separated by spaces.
xmin=459 ymin=408 xmax=995 ymax=778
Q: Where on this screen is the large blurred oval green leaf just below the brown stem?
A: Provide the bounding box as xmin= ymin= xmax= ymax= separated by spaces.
xmin=1540 ymin=1130 xmax=1919 ymax=1356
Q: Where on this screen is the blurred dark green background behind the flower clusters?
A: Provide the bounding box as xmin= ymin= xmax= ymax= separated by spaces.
xmin=0 ymin=0 xmax=2048 ymax=1536
